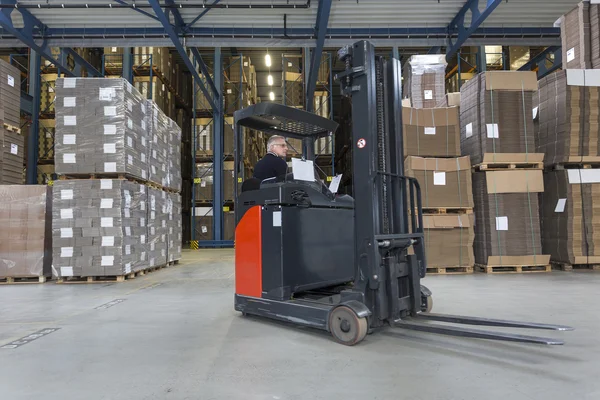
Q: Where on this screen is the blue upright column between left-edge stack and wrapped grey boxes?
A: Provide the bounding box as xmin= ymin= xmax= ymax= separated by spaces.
xmin=27 ymin=50 xmax=42 ymax=185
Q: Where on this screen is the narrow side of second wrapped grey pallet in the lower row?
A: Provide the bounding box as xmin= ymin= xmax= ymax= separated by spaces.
xmin=148 ymin=188 xmax=169 ymax=267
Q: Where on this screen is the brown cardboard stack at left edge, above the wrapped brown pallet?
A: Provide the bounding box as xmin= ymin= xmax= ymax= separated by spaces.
xmin=0 ymin=60 xmax=25 ymax=185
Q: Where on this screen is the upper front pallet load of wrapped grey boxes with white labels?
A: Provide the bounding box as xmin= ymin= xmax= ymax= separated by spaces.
xmin=55 ymin=78 xmax=149 ymax=179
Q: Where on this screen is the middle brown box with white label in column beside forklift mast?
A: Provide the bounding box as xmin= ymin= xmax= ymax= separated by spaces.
xmin=404 ymin=156 xmax=473 ymax=208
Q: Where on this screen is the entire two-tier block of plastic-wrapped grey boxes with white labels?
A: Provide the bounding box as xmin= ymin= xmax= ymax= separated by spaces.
xmin=52 ymin=78 xmax=181 ymax=283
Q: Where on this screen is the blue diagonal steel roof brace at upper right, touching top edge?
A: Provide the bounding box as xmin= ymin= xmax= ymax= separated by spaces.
xmin=446 ymin=0 xmax=502 ymax=61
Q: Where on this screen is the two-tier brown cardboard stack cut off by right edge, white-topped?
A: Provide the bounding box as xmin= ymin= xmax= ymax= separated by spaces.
xmin=535 ymin=69 xmax=600 ymax=271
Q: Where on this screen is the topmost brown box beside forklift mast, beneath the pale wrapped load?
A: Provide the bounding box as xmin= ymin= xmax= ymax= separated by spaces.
xmin=402 ymin=107 xmax=460 ymax=157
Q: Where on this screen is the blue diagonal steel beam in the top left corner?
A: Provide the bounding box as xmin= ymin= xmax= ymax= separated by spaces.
xmin=0 ymin=0 xmax=75 ymax=76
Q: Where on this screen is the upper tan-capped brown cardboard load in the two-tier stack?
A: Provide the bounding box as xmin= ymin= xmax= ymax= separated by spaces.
xmin=460 ymin=71 xmax=537 ymax=165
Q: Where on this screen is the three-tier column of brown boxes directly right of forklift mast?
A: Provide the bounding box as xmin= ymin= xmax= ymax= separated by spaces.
xmin=402 ymin=90 xmax=474 ymax=274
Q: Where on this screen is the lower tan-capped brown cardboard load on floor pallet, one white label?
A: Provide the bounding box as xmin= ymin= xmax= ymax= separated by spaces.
xmin=473 ymin=170 xmax=550 ymax=266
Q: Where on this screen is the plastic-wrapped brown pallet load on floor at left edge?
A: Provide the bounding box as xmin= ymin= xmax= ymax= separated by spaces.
xmin=0 ymin=185 xmax=51 ymax=278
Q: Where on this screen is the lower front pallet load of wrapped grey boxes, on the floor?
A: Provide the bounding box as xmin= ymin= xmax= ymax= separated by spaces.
xmin=52 ymin=179 xmax=148 ymax=277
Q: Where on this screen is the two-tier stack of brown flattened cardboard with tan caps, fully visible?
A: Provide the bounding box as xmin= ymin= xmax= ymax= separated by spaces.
xmin=460 ymin=71 xmax=551 ymax=273
